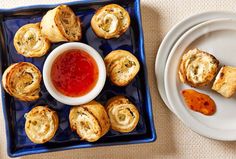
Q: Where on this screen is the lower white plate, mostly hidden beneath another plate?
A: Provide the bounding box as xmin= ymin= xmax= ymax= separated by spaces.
xmin=155 ymin=12 xmax=236 ymax=112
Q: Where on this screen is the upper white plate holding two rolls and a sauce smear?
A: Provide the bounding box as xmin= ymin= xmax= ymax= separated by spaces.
xmin=164 ymin=19 xmax=236 ymax=140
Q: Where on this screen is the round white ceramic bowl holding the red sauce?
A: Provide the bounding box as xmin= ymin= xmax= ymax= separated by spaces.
xmin=43 ymin=42 xmax=106 ymax=105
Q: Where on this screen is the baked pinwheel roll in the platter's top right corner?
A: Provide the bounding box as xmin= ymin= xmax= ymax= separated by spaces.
xmin=91 ymin=4 xmax=130 ymax=39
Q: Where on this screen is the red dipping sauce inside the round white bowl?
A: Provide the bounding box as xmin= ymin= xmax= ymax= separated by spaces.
xmin=51 ymin=49 xmax=99 ymax=97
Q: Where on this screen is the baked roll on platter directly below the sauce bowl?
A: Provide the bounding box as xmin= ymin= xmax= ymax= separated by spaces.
xmin=69 ymin=101 xmax=110 ymax=142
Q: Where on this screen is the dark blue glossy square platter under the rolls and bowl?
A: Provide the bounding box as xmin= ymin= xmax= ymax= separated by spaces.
xmin=0 ymin=0 xmax=156 ymax=157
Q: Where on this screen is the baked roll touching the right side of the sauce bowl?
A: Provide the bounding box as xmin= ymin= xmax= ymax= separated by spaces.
xmin=104 ymin=50 xmax=140 ymax=86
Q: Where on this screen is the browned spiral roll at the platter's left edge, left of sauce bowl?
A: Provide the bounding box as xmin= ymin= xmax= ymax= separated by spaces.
xmin=2 ymin=62 xmax=41 ymax=101
